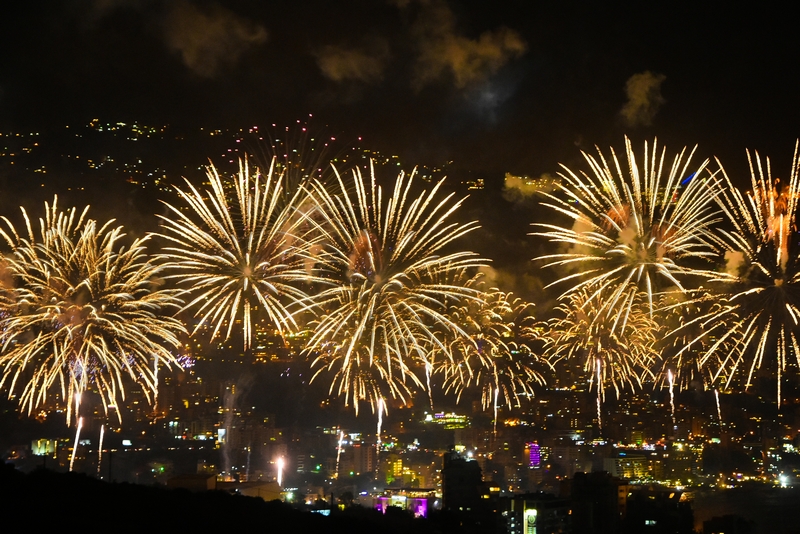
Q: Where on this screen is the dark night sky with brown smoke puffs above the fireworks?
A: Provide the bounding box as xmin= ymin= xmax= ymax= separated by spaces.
xmin=0 ymin=0 xmax=800 ymax=180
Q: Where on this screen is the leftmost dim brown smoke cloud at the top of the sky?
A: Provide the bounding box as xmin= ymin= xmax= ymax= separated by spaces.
xmin=163 ymin=0 xmax=267 ymax=78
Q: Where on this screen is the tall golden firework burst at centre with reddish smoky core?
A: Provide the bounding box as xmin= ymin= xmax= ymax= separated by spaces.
xmin=306 ymin=163 xmax=484 ymax=412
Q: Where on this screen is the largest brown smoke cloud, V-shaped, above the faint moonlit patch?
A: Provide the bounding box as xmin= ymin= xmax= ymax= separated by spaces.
xmin=412 ymin=0 xmax=527 ymax=90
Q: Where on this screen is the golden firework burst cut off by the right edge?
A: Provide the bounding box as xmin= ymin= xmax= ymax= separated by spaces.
xmin=683 ymin=145 xmax=800 ymax=407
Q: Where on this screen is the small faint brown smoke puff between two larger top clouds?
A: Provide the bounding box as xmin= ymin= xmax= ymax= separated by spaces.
xmin=316 ymin=41 xmax=389 ymax=83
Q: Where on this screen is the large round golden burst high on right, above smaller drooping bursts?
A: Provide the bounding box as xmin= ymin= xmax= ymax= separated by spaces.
xmin=533 ymin=137 xmax=719 ymax=314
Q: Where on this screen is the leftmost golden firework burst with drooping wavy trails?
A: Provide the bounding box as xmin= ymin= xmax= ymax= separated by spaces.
xmin=0 ymin=199 xmax=186 ymax=424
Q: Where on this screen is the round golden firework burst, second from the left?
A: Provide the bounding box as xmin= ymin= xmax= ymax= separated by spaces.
xmin=160 ymin=159 xmax=318 ymax=350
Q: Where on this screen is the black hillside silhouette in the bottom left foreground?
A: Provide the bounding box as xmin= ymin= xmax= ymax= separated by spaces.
xmin=0 ymin=464 xmax=460 ymax=534
